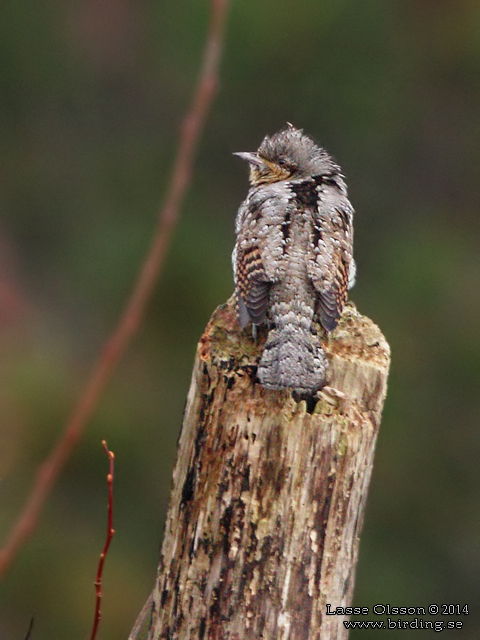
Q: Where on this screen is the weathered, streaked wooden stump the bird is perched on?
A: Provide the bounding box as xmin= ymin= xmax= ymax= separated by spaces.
xmin=130 ymin=298 xmax=390 ymax=640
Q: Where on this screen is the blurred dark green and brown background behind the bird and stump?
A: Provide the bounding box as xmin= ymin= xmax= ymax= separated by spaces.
xmin=0 ymin=0 xmax=480 ymax=640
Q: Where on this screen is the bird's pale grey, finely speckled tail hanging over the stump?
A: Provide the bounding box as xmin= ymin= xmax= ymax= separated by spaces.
xmin=257 ymin=323 xmax=327 ymax=394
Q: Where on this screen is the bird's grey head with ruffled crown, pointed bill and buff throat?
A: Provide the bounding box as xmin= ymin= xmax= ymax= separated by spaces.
xmin=235 ymin=124 xmax=338 ymax=186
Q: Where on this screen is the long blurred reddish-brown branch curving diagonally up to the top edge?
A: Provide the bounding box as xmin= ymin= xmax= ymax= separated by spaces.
xmin=0 ymin=0 xmax=229 ymax=577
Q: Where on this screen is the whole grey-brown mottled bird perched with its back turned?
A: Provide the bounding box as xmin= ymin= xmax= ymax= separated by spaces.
xmin=232 ymin=125 xmax=355 ymax=394
